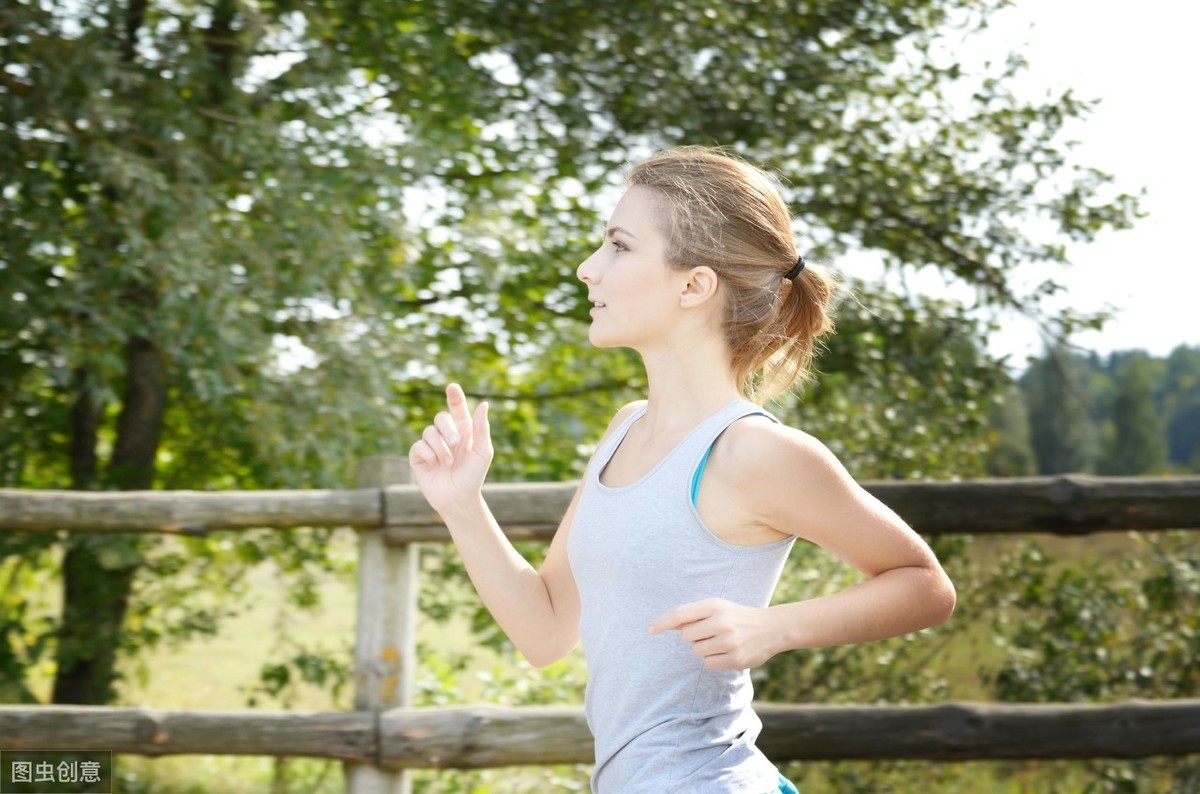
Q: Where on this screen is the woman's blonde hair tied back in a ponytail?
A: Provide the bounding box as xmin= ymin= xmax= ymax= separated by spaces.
xmin=625 ymin=146 xmax=834 ymax=399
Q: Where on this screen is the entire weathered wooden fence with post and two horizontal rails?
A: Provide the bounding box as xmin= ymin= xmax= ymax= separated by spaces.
xmin=0 ymin=470 xmax=1200 ymax=794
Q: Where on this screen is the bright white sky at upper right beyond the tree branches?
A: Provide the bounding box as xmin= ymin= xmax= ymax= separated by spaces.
xmin=859 ymin=0 xmax=1200 ymax=363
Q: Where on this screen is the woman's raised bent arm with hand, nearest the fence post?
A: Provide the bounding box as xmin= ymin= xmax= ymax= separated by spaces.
xmin=409 ymin=384 xmax=631 ymax=667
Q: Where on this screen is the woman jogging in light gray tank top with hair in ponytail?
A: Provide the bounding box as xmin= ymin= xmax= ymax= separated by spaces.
xmin=409 ymin=148 xmax=954 ymax=794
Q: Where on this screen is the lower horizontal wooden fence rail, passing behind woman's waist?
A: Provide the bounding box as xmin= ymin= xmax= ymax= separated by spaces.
xmin=0 ymin=699 xmax=1200 ymax=769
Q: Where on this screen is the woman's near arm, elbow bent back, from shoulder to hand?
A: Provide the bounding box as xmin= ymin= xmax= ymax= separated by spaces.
xmin=650 ymin=422 xmax=955 ymax=669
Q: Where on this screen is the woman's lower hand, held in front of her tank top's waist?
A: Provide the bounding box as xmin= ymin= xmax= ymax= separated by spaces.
xmin=650 ymin=598 xmax=778 ymax=670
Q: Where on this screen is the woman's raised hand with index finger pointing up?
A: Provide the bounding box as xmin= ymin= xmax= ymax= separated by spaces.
xmin=408 ymin=384 xmax=493 ymax=513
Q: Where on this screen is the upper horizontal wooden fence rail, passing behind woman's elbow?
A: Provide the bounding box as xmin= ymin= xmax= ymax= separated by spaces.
xmin=0 ymin=475 xmax=1200 ymax=545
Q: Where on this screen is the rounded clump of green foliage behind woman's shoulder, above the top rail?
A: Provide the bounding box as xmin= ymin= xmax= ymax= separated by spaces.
xmin=779 ymin=283 xmax=1004 ymax=480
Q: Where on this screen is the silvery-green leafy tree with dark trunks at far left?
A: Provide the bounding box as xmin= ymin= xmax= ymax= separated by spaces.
xmin=0 ymin=2 xmax=452 ymax=703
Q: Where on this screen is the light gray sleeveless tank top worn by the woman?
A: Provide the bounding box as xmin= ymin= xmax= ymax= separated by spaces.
xmin=568 ymin=401 xmax=794 ymax=794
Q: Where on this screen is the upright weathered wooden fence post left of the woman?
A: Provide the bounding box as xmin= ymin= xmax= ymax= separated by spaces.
xmin=346 ymin=456 xmax=420 ymax=794
